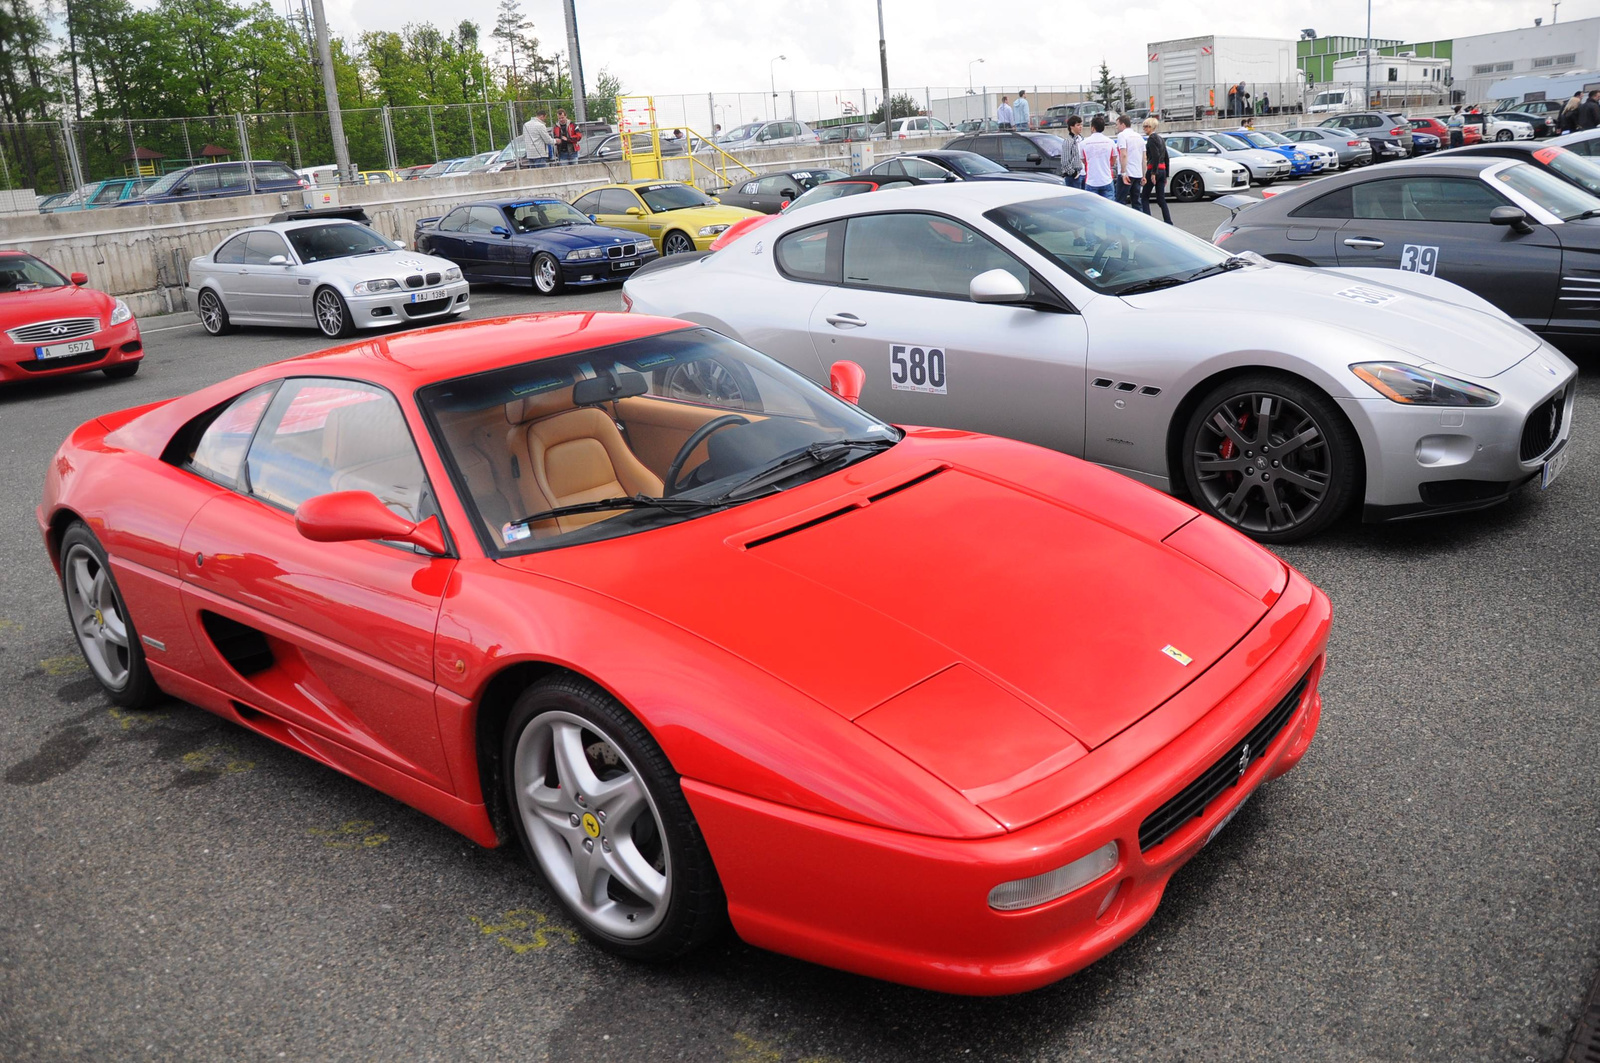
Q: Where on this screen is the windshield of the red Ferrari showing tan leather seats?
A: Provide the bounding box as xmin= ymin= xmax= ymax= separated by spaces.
xmin=418 ymin=328 xmax=901 ymax=554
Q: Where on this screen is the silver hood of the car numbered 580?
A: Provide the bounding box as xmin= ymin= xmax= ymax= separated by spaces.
xmin=1125 ymin=264 xmax=1539 ymax=378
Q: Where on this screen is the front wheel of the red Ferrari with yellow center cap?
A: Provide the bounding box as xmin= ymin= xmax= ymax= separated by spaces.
xmin=501 ymin=676 xmax=728 ymax=961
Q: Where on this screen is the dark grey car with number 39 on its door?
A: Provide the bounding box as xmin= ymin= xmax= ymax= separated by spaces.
xmin=1213 ymin=154 xmax=1600 ymax=344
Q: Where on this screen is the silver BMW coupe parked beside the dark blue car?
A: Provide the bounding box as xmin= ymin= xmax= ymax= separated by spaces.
xmin=189 ymin=218 xmax=467 ymax=336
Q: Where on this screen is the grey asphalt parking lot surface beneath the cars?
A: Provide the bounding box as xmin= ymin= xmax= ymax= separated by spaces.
xmin=0 ymin=192 xmax=1600 ymax=1063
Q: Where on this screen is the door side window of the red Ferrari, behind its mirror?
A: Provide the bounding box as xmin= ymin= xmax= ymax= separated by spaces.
xmin=246 ymin=378 xmax=427 ymax=520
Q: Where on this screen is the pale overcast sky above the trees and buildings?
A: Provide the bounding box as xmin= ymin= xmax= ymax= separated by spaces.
xmin=318 ymin=0 xmax=1600 ymax=94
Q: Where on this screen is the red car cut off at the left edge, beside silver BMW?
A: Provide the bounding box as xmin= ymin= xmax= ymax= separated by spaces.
xmin=0 ymin=250 xmax=144 ymax=381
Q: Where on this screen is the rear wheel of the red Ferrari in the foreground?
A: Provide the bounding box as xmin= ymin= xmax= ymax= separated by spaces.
xmin=61 ymin=522 xmax=160 ymax=709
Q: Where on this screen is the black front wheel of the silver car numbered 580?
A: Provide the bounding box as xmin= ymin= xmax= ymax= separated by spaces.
xmin=1181 ymin=371 xmax=1360 ymax=543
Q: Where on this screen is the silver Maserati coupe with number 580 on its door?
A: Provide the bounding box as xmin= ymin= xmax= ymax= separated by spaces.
xmin=624 ymin=183 xmax=1576 ymax=543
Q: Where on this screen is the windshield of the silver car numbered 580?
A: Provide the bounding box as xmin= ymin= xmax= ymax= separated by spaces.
xmin=984 ymin=195 xmax=1235 ymax=295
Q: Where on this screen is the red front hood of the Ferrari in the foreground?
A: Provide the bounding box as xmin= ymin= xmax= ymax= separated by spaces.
xmin=518 ymin=463 xmax=1266 ymax=752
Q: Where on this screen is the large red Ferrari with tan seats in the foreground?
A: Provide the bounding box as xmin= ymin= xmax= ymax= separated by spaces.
xmin=38 ymin=314 xmax=1330 ymax=994
